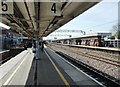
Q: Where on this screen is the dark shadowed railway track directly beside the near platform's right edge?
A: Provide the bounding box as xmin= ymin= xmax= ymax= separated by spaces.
xmin=56 ymin=51 xmax=120 ymax=87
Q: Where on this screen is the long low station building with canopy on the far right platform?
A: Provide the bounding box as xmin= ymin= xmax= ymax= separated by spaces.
xmin=49 ymin=33 xmax=120 ymax=47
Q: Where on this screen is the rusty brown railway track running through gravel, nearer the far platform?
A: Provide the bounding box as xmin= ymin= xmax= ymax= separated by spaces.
xmin=49 ymin=46 xmax=120 ymax=67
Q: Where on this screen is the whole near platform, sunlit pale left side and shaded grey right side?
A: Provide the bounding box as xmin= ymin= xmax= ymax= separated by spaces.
xmin=1 ymin=47 xmax=102 ymax=87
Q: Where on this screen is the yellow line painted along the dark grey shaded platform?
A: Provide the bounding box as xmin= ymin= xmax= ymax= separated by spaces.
xmin=44 ymin=50 xmax=70 ymax=87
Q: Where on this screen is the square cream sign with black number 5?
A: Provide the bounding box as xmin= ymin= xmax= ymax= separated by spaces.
xmin=0 ymin=0 xmax=13 ymax=14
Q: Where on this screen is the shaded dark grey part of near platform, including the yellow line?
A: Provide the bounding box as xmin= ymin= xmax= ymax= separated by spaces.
xmin=26 ymin=47 xmax=100 ymax=87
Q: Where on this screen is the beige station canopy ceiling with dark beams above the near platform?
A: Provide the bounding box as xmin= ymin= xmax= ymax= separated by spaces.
xmin=1 ymin=0 xmax=100 ymax=37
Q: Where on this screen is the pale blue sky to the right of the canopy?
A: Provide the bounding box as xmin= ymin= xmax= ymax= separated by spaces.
xmin=43 ymin=0 xmax=120 ymax=39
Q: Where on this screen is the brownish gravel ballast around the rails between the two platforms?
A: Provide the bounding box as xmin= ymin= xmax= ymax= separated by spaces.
xmin=48 ymin=44 xmax=120 ymax=79
